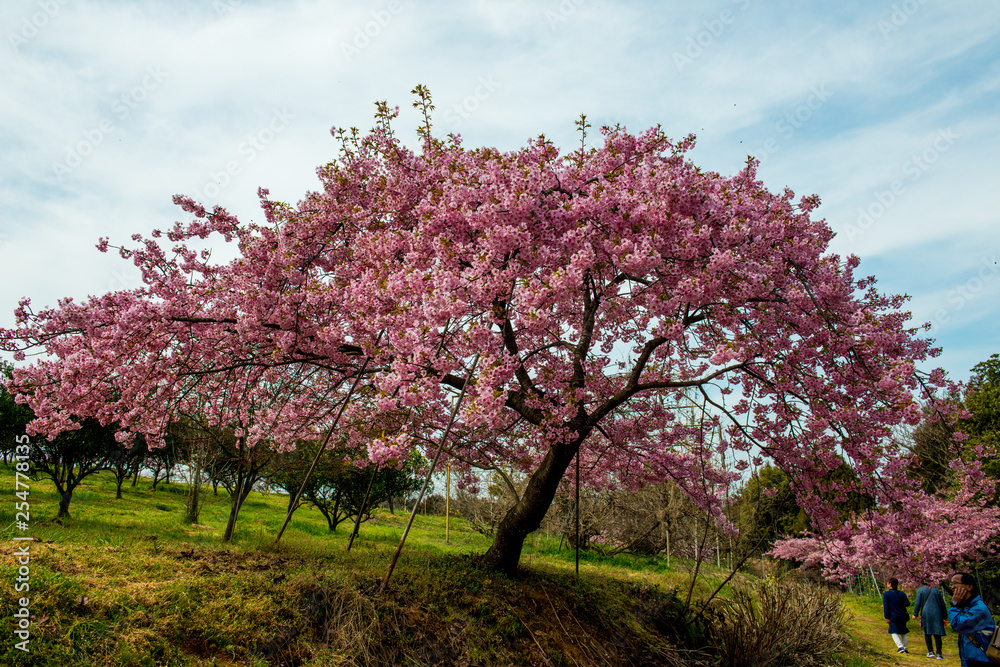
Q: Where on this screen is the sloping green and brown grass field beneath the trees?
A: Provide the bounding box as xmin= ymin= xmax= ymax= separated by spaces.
xmin=0 ymin=466 xmax=957 ymax=667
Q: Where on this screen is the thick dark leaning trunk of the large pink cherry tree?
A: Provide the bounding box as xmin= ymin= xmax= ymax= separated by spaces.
xmin=483 ymin=433 xmax=587 ymax=575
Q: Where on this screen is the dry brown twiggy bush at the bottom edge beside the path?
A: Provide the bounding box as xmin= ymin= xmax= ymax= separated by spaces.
xmin=713 ymin=578 xmax=846 ymax=667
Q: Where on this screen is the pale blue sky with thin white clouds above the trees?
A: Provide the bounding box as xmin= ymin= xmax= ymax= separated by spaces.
xmin=0 ymin=0 xmax=1000 ymax=380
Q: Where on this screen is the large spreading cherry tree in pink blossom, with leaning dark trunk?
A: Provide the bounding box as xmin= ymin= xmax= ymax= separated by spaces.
xmin=3 ymin=87 xmax=960 ymax=572
